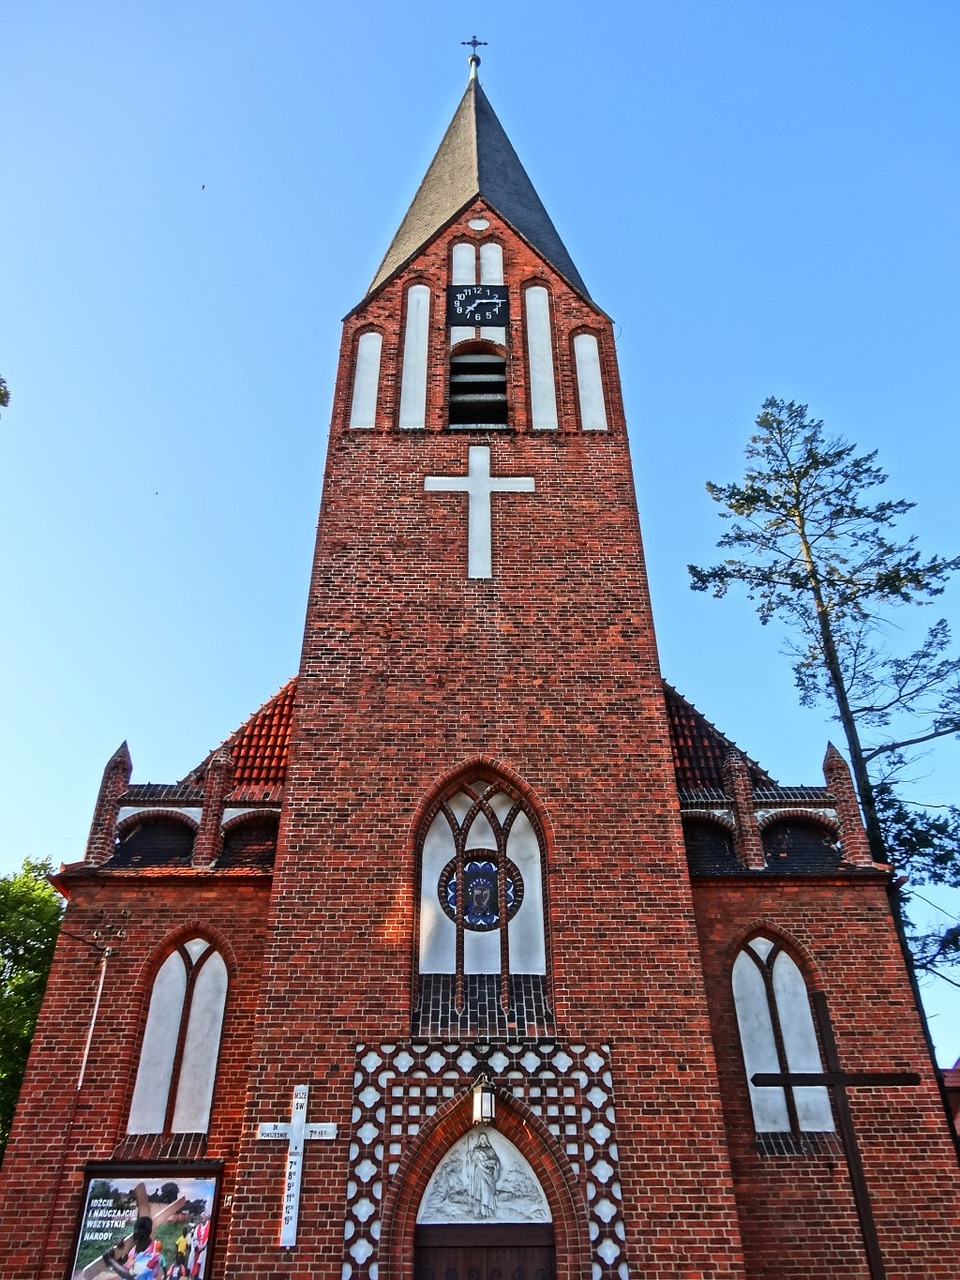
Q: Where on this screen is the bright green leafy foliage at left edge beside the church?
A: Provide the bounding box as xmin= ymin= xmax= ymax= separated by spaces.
xmin=0 ymin=859 xmax=63 ymax=1152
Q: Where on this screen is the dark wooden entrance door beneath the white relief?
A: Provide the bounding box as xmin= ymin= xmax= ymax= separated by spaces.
xmin=413 ymin=1222 xmax=554 ymax=1280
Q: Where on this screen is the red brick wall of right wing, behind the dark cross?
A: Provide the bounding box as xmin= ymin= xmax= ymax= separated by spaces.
xmin=694 ymin=873 xmax=960 ymax=1280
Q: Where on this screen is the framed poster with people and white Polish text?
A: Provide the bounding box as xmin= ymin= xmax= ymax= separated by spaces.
xmin=70 ymin=1167 xmax=218 ymax=1280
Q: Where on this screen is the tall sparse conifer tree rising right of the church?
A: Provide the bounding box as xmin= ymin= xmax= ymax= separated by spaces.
xmin=689 ymin=399 xmax=960 ymax=968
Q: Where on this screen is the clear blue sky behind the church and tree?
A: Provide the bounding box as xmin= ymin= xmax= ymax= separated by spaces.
xmin=0 ymin=0 xmax=960 ymax=1062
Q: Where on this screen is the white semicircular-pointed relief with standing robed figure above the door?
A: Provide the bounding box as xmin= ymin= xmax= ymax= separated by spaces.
xmin=417 ymin=1126 xmax=550 ymax=1224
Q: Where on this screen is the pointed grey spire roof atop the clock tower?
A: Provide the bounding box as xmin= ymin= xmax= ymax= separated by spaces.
xmin=367 ymin=79 xmax=590 ymax=297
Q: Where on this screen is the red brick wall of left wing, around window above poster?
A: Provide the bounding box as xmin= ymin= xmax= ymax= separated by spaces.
xmin=0 ymin=868 xmax=269 ymax=1280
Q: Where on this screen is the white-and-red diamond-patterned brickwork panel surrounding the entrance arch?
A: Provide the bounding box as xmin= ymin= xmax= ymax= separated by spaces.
xmin=342 ymin=1041 xmax=630 ymax=1280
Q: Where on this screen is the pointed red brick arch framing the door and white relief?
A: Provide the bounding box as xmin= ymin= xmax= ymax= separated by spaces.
xmin=380 ymin=1089 xmax=591 ymax=1280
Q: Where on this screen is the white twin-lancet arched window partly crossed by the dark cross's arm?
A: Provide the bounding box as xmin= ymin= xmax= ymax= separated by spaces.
xmin=733 ymin=936 xmax=835 ymax=1135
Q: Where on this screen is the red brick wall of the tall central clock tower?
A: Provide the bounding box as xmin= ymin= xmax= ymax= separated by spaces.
xmin=217 ymin=205 xmax=741 ymax=1277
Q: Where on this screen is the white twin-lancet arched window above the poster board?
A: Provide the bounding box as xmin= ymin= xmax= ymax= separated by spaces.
xmin=127 ymin=937 xmax=227 ymax=1134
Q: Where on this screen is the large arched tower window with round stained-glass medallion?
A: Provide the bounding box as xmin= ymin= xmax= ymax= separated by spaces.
xmin=417 ymin=778 xmax=550 ymax=1034
